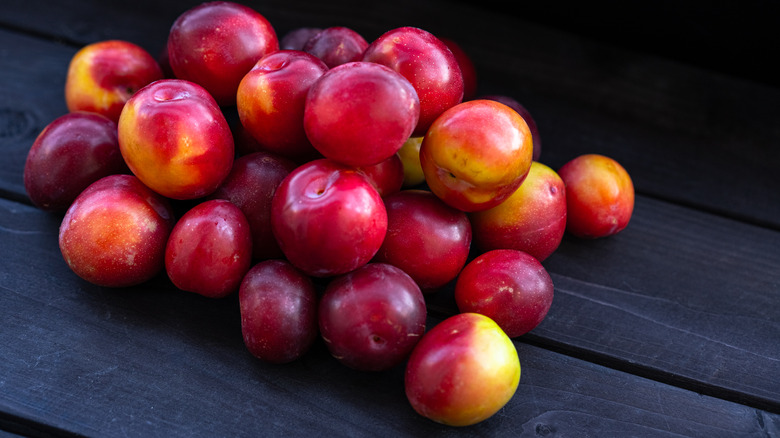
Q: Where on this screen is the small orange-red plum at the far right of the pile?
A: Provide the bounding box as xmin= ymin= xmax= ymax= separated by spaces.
xmin=558 ymin=154 xmax=634 ymax=239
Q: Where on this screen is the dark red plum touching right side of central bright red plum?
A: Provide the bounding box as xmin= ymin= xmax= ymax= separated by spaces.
xmin=374 ymin=189 xmax=472 ymax=293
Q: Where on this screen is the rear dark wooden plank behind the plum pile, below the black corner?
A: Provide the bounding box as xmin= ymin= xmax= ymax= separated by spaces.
xmin=3 ymin=0 xmax=780 ymax=229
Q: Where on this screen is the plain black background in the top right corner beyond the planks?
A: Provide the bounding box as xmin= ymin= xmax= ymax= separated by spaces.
xmin=461 ymin=0 xmax=780 ymax=86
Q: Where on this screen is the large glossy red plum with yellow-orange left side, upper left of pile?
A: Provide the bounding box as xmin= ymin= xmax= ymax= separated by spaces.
xmin=118 ymin=79 xmax=235 ymax=200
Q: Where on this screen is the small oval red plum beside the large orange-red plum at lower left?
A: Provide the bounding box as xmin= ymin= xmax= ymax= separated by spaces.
xmin=165 ymin=199 xmax=252 ymax=298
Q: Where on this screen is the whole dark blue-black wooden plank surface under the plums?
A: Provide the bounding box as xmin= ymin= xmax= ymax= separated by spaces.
xmin=0 ymin=0 xmax=780 ymax=437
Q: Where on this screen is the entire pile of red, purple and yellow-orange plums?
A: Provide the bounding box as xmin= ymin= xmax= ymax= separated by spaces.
xmin=24 ymin=1 xmax=634 ymax=425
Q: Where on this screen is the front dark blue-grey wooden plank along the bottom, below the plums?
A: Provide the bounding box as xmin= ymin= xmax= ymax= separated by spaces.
xmin=0 ymin=200 xmax=780 ymax=437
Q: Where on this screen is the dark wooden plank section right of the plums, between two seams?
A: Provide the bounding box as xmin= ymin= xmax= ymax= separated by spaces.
xmin=429 ymin=193 xmax=780 ymax=411
